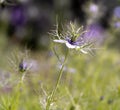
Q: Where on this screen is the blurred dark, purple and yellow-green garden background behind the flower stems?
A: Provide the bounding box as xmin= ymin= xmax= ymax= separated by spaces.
xmin=0 ymin=0 xmax=120 ymax=110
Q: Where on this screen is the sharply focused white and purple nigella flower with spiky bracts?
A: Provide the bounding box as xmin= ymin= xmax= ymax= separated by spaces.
xmin=52 ymin=22 xmax=92 ymax=54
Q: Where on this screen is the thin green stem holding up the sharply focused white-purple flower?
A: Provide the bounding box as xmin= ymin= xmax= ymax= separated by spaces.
xmin=46 ymin=50 xmax=69 ymax=110
